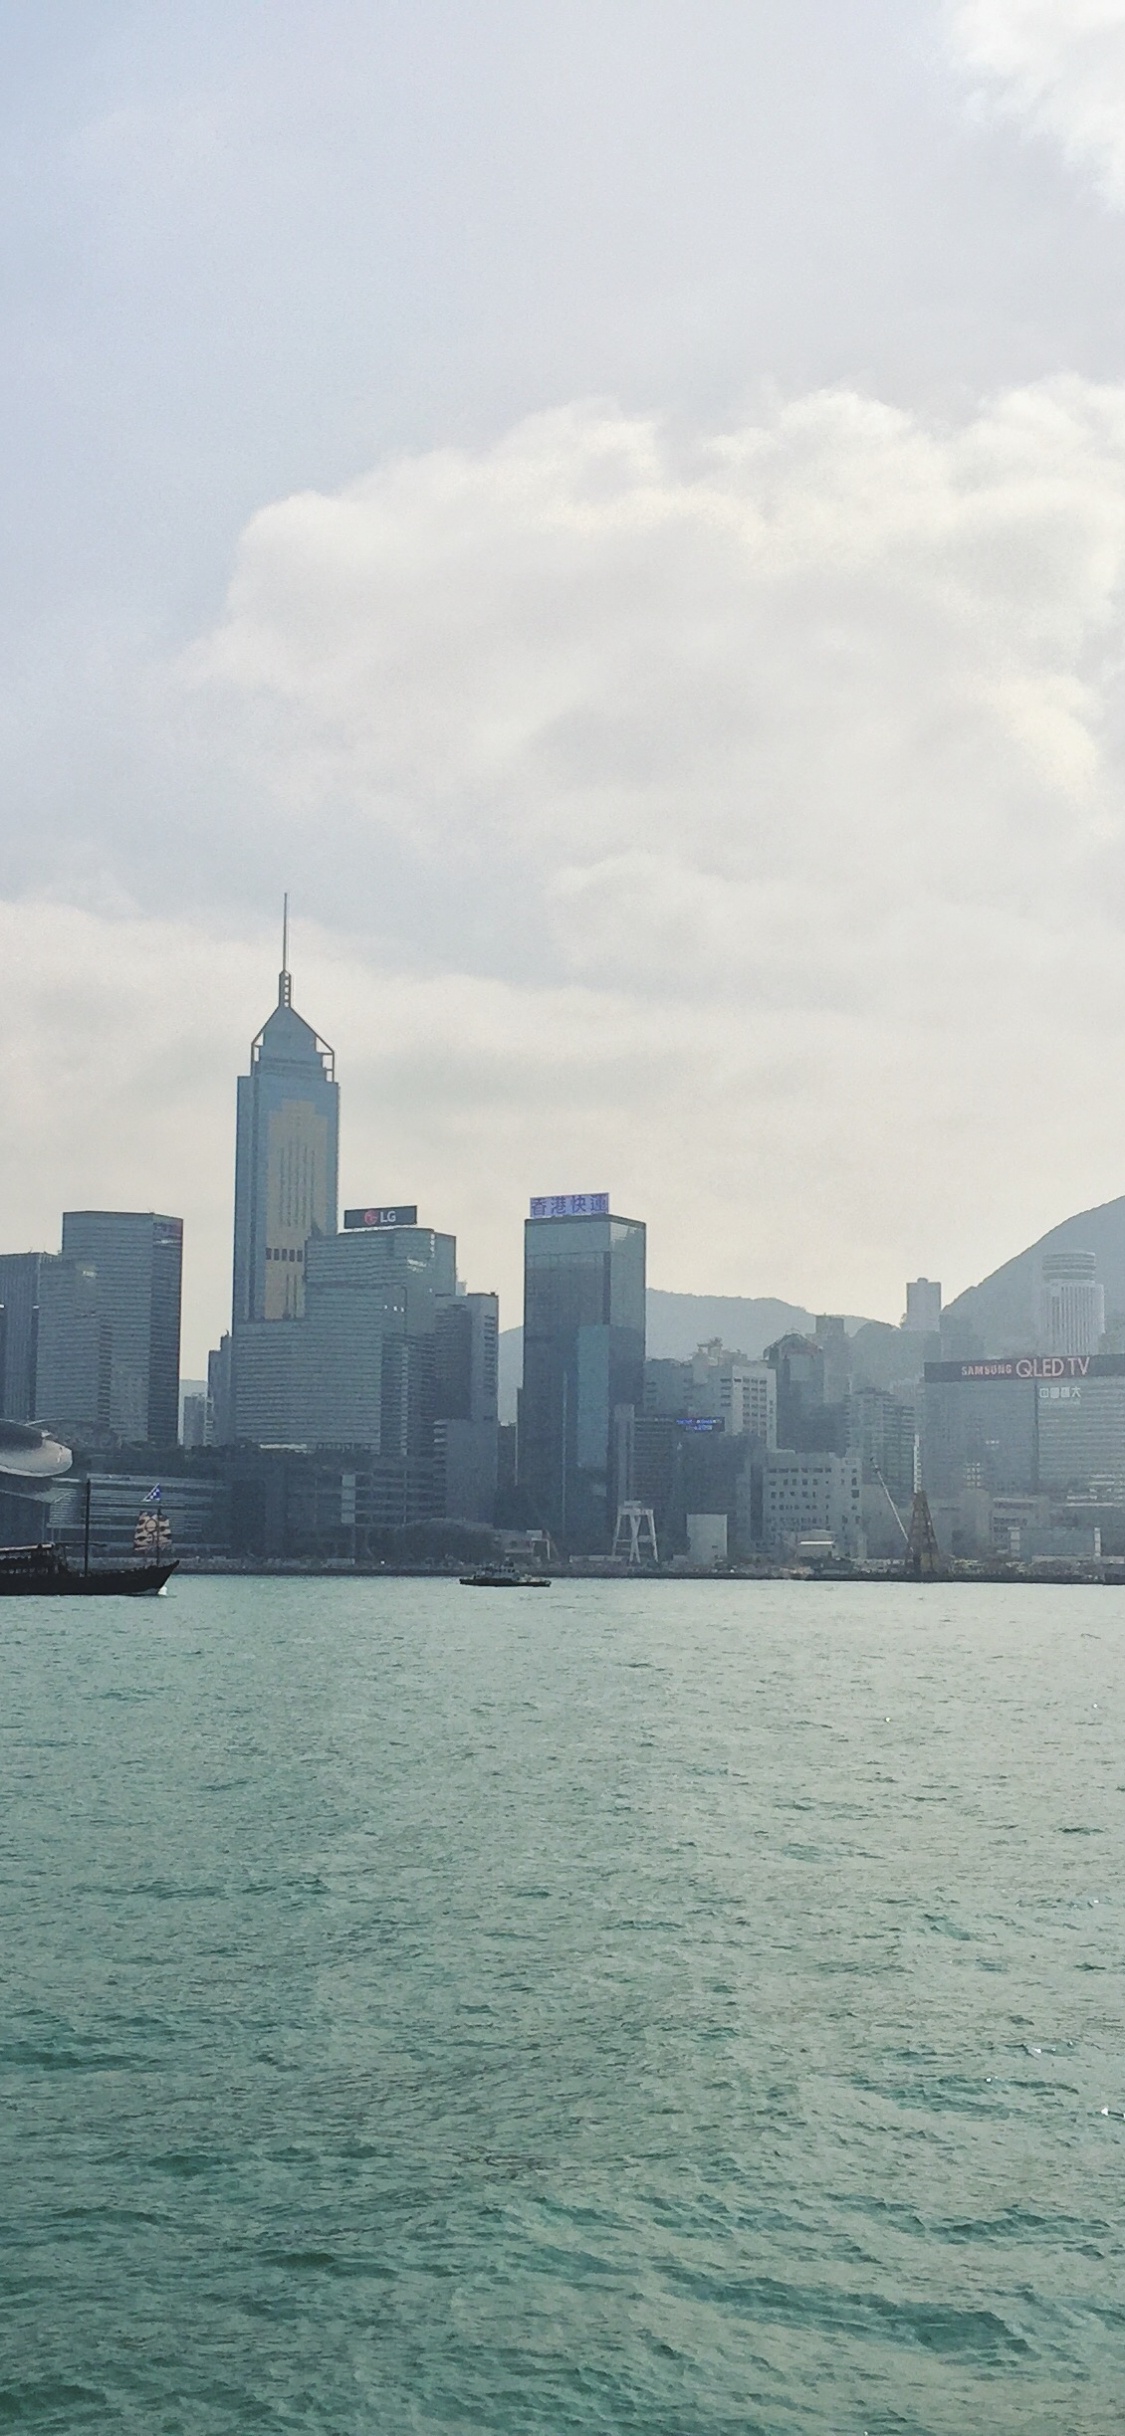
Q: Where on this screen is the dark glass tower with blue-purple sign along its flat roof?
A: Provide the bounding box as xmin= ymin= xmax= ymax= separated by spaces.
xmin=519 ymin=1211 xmax=645 ymax=1554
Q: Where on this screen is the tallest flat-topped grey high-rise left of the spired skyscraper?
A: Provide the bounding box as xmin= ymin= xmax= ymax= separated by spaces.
xmin=37 ymin=1211 xmax=183 ymax=1447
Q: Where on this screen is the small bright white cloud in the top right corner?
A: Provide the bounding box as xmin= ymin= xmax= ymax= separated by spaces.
xmin=947 ymin=0 xmax=1125 ymax=205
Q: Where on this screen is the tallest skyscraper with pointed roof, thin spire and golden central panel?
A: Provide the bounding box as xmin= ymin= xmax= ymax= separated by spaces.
xmin=234 ymin=899 xmax=338 ymax=1330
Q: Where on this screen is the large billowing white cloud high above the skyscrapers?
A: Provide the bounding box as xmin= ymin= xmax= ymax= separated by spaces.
xmin=192 ymin=380 xmax=1125 ymax=915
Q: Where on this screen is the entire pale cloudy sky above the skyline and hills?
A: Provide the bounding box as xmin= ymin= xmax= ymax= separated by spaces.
xmin=0 ymin=0 xmax=1125 ymax=1376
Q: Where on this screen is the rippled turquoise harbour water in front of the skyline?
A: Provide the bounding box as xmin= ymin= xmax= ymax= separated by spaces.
xmin=0 ymin=1581 xmax=1125 ymax=2436
